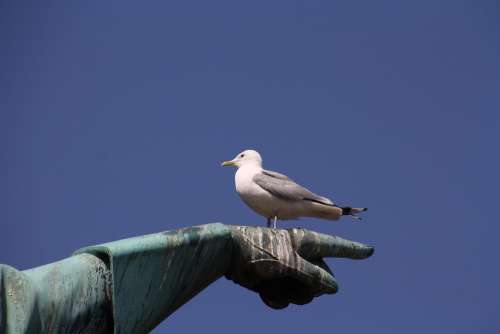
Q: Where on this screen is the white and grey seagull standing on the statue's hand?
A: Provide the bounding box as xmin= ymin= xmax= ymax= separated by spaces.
xmin=221 ymin=150 xmax=368 ymax=228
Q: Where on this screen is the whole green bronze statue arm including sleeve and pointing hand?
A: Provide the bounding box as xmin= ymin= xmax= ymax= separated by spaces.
xmin=0 ymin=223 xmax=373 ymax=334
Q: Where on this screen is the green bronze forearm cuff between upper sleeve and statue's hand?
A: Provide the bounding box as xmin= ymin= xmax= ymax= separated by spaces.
xmin=75 ymin=224 xmax=231 ymax=333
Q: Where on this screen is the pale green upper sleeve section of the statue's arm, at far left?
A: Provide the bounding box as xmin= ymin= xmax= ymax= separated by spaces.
xmin=0 ymin=254 xmax=112 ymax=334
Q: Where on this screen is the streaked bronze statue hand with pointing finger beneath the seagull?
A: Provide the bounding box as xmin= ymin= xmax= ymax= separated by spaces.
xmin=226 ymin=226 xmax=374 ymax=309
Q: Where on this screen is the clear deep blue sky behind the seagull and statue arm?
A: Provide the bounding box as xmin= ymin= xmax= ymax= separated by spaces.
xmin=0 ymin=0 xmax=500 ymax=333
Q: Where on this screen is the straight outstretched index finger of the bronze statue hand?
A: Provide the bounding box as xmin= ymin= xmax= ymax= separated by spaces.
xmin=288 ymin=229 xmax=375 ymax=259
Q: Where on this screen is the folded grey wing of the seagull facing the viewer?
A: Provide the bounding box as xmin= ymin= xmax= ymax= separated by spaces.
xmin=253 ymin=170 xmax=333 ymax=205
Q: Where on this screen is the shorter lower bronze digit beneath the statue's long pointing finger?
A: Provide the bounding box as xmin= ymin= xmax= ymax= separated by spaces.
xmin=288 ymin=256 xmax=339 ymax=296
